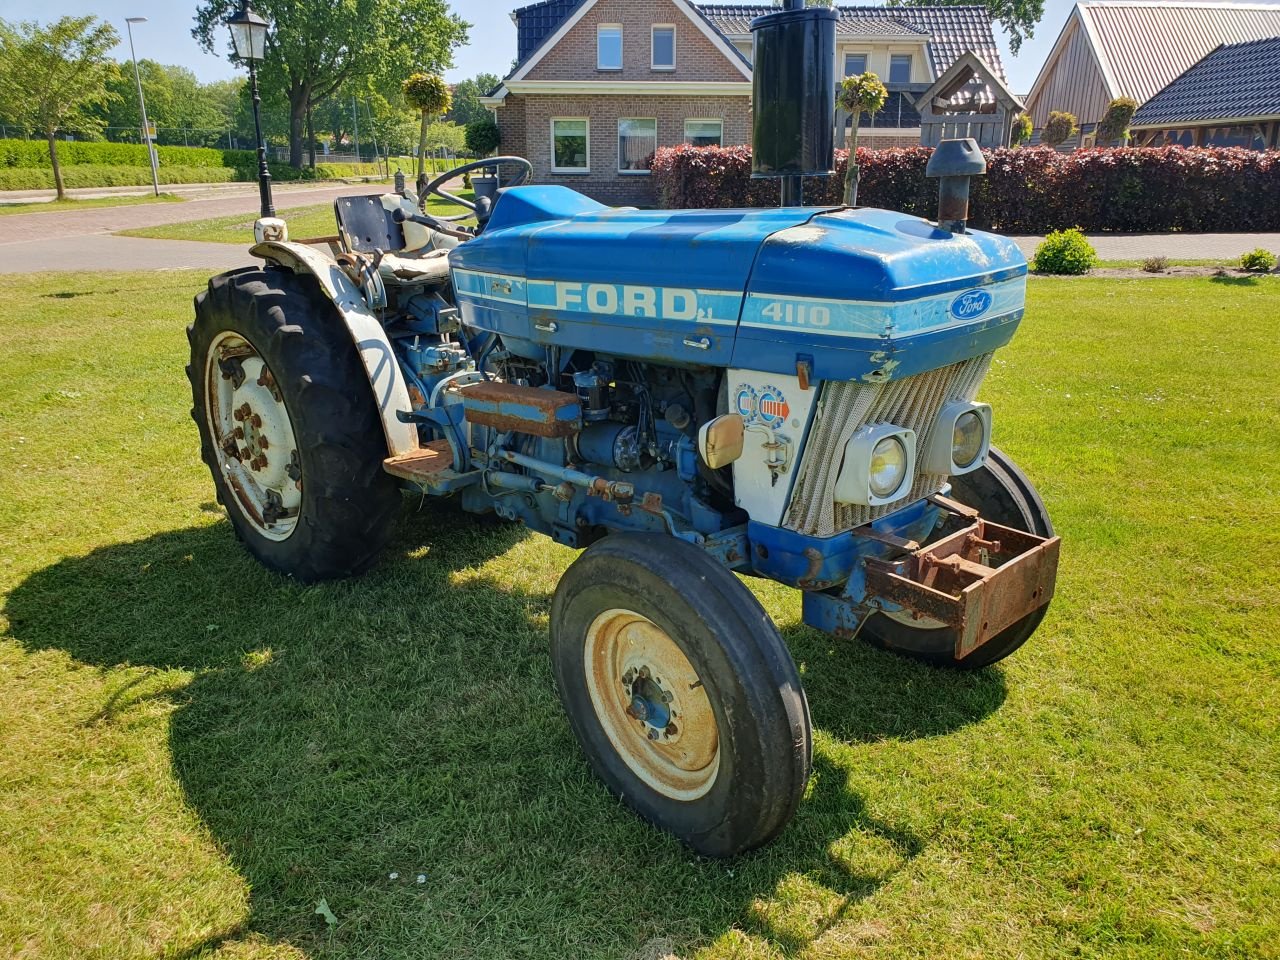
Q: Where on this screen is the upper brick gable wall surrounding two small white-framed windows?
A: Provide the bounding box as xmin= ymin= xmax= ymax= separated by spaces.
xmin=524 ymin=0 xmax=746 ymax=82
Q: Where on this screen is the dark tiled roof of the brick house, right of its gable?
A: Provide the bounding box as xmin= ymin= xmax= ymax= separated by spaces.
xmin=698 ymin=4 xmax=1005 ymax=79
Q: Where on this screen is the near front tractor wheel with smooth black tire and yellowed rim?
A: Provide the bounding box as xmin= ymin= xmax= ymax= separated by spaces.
xmin=550 ymin=532 xmax=813 ymax=858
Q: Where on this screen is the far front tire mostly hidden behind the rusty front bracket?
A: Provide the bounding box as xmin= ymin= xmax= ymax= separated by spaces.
xmin=861 ymin=447 xmax=1053 ymax=669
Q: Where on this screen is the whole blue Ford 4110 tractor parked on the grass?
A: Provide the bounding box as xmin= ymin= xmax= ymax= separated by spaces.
xmin=188 ymin=0 xmax=1059 ymax=856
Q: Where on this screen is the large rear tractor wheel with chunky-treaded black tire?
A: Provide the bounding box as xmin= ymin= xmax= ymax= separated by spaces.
xmin=187 ymin=266 xmax=401 ymax=582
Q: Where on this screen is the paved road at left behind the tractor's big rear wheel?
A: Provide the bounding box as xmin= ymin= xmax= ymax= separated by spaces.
xmin=0 ymin=184 xmax=379 ymax=274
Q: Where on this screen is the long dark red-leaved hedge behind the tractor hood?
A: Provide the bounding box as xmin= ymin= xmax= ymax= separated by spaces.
xmin=653 ymin=146 xmax=1280 ymax=233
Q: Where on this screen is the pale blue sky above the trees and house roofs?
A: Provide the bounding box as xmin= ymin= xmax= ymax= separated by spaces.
xmin=0 ymin=0 xmax=1274 ymax=93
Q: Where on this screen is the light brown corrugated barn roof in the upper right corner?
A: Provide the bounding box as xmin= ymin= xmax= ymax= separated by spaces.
xmin=1079 ymin=0 xmax=1280 ymax=104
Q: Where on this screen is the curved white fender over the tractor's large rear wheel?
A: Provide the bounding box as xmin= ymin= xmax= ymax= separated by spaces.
xmin=250 ymin=241 xmax=419 ymax=457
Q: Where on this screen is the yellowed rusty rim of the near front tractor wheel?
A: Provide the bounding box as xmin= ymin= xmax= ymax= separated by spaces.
xmin=584 ymin=609 xmax=719 ymax=800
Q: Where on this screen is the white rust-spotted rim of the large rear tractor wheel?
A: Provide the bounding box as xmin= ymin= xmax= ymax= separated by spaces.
xmin=205 ymin=332 xmax=302 ymax=540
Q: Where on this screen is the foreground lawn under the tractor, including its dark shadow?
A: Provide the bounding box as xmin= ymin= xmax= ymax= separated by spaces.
xmin=0 ymin=273 xmax=1280 ymax=960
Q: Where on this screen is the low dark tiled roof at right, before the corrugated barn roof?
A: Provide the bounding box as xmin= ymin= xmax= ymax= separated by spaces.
xmin=1133 ymin=36 xmax=1280 ymax=127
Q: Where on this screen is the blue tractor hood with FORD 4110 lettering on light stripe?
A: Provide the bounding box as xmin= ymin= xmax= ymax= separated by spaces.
xmin=449 ymin=187 xmax=1027 ymax=379
